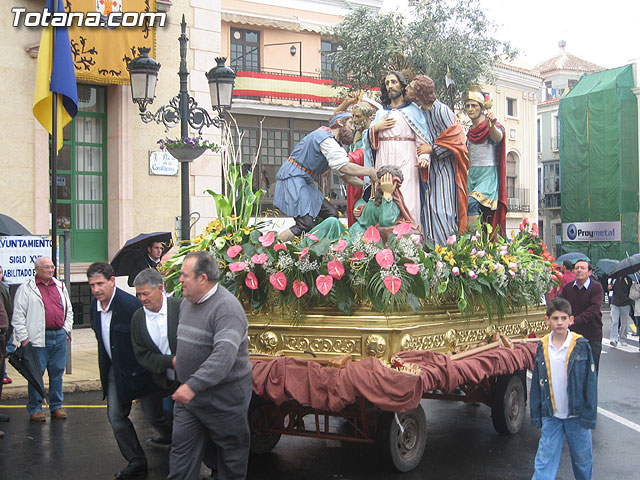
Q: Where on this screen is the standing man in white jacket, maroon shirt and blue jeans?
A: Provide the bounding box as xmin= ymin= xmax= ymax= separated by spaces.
xmin=11 ymin=257 xmax=73 ymax=422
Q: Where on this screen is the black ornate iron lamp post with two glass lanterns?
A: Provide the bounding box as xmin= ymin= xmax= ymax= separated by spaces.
xmin=127 ymin=15 xmax=236 ymax=242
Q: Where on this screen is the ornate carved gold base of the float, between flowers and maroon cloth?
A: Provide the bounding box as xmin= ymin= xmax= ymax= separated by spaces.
xmin=247 ymin=307 xmax=548 ymax=361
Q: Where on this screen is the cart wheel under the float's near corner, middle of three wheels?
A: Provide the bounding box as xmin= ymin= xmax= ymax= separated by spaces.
xmin=376 ymin=406 xmax=427 ymax=472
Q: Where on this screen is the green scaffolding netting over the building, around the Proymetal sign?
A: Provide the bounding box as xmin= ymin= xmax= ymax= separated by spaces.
xmin=558 ymin=65 xmax=638 ymax=263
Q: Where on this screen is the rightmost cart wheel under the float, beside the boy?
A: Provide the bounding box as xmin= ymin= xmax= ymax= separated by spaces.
xmin=491 ymin=374 xmax=525 ymax=435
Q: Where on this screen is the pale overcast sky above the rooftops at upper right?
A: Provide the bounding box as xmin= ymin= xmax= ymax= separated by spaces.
xmin=385 ymin=0 xmax=640 ymax=68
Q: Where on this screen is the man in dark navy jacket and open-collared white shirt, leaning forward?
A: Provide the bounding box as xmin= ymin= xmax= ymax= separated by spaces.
xmin=87 ymin=262 xmax=171 ymax=479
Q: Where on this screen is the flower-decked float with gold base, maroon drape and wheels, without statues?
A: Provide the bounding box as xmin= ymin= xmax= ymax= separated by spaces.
xmin=165 ymin=155 xmax=558 ymax=471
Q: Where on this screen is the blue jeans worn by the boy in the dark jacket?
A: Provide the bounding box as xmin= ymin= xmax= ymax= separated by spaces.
xmin=532 ymin=417 xmax=593 ymax=480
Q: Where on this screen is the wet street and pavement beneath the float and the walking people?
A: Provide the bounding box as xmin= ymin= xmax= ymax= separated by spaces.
xmin=0 ymin=312 xmax=640 ymax=480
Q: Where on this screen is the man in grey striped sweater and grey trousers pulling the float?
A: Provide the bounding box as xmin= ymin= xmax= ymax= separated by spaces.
xmin=168 ymin=252 xmax=251 ymax=480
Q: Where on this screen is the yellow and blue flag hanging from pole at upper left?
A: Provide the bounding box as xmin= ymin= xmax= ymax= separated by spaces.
xmin=33 ymin=0 xmax=78 ymax=151
